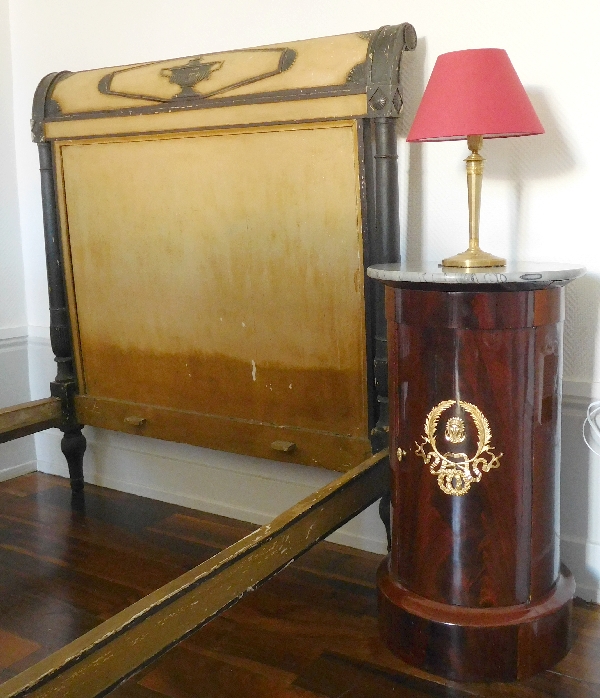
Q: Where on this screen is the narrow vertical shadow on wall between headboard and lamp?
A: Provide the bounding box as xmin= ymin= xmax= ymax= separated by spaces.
xmin=399 ymin=37 xmax=427 ymax=266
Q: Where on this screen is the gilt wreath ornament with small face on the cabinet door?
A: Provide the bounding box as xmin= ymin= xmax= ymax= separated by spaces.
xmin=415 ymin=400 xmax=503 ymax=496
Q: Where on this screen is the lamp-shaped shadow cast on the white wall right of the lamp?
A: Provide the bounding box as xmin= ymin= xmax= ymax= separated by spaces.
xmin=482 ymin=90 xmax=576 ymax=261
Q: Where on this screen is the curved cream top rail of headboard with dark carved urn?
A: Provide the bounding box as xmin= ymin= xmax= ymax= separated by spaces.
xmin=32 ymin=23 xmax=416 ymax=142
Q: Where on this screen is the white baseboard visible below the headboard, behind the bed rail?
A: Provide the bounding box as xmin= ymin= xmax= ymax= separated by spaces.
xmin=36 ymin=428 xmax=386 ymax=554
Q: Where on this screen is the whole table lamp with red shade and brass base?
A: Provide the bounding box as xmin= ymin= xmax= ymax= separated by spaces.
xmin=406 ymin=48 xmax=544 ymax=268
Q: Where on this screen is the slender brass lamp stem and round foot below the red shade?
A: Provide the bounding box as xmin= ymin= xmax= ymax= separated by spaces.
xmin=442 ymin=136 xmax=506 ymax=268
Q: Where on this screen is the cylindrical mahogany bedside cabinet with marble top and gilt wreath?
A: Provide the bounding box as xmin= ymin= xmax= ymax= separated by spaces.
xmin=368 ymin=264 xmax=584 ymax=681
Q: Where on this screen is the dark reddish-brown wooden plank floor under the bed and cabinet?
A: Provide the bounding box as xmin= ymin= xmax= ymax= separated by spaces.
xmin=0 ymin=474 xmax=600 ymax=698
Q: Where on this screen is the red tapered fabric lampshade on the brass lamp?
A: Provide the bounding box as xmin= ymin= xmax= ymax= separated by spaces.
xmin=406 ymin=48 xmax=544 ymax=141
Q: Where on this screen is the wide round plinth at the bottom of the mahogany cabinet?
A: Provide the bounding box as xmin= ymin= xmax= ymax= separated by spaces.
xmin=377 ymin=558 xmax=575 ymax=681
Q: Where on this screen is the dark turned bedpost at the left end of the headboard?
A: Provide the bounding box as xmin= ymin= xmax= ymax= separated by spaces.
xmin=31 ymin=73 xmax=86 ymax=494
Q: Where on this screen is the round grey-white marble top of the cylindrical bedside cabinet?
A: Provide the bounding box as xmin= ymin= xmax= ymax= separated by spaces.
xmin=367 ymin=262 xmax=585 ymax=288
